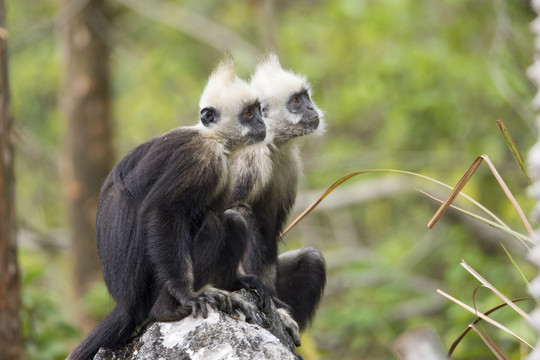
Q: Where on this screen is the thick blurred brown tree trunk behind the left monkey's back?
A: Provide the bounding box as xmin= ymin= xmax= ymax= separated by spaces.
xmin=61 ymin=0 xmax=114 ymax=296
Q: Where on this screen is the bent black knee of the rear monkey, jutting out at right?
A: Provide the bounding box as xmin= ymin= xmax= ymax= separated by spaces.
xmin=277 ymin=247 xmax=326 ymax=330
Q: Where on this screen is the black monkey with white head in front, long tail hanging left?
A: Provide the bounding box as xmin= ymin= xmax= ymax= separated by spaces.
xmin=68 ymin=57 xmax=266 ymax=360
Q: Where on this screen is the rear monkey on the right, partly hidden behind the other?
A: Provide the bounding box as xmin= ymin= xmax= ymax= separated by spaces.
xmin=230 ymin=53 xmax=326 ymax=346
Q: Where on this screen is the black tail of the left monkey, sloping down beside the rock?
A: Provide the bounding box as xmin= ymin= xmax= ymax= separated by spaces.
xmin=66 ymin=306 xmax=137 ymax=360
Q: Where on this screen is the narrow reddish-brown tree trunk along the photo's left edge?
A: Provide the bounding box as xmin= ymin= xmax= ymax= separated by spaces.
xmin=0 ymin=0 xmax=24 ymax=360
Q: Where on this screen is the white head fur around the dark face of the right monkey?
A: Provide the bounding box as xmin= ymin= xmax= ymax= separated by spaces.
xmin=250 ymin=53 xmax=325 ymax=142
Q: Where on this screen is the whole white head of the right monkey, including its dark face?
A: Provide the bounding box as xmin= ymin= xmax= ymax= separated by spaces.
xmin=250 ymin=53 xmax=325 ymax=146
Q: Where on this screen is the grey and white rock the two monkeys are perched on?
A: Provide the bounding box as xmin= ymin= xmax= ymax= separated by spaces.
xmin=94 ymin=290 xmax=302 ymax=360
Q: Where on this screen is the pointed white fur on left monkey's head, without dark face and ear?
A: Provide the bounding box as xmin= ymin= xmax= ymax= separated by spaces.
xmin=199 ymin=56 xmax=258 ymax=146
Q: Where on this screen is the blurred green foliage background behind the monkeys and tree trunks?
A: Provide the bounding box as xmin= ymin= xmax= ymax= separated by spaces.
xmin=7 ymin=0 xmax=536 ymax=359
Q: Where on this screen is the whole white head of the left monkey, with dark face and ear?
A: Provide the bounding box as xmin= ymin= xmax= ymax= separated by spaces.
xmin=199 ymin=55 xmax=266 ymax=149
